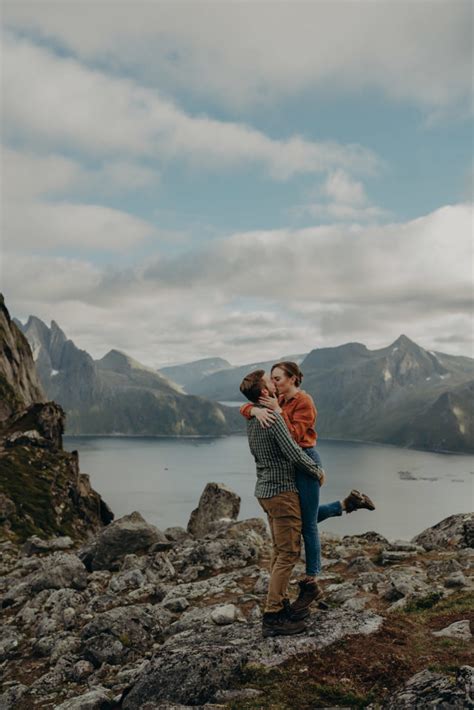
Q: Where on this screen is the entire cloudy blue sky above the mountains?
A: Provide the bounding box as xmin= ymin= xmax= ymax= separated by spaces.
xmin=0 ymin=0 xmax=473 ymax=367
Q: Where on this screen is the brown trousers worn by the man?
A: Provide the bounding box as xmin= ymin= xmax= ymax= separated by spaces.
xmin=258 ymin=491 xmax=301 ymax=612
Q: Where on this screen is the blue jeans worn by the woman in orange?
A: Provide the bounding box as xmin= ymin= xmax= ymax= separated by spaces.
xmin=296 ymin=446 xmax=342 ymax=576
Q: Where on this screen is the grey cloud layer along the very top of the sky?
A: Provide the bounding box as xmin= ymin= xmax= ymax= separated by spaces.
xmin=4 ymin=0 xmax=472 ymax=113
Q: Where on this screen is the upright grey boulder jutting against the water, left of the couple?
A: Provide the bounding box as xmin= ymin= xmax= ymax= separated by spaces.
xmin=187 ymin=483 xmax=240 ymax=537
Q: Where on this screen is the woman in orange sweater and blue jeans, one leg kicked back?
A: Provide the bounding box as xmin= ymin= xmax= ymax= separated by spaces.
xmin=240 ymin=361 xmax=375 ymax=584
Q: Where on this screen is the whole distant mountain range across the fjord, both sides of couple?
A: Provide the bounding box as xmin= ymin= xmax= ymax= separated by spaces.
xmin=16 ymin=316 xmax=474 ymax=452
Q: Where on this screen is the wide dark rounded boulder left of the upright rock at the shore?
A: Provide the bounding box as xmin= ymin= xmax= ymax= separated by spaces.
xmin=79 ymin=512 xmax=168 ymax=571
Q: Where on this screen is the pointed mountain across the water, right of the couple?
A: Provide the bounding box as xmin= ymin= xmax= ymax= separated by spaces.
xmin=301 ymin=335 xmax=474 ymax=451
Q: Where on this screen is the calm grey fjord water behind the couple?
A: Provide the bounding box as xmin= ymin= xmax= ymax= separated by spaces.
xmin=65 ymin=436 xmax=474 ymax=540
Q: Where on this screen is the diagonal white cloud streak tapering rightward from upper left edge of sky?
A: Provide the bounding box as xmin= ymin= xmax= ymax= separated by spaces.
xmin=3 ymin=34 xmax=378 ymax=179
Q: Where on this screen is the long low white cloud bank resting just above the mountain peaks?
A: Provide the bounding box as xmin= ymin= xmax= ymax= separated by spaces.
xmin=2 ymin=205 xmax=472 ymax=366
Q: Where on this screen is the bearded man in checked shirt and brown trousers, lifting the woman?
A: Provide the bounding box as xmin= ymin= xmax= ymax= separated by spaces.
xmin=240 ymin=370 xmax=325 ymax=636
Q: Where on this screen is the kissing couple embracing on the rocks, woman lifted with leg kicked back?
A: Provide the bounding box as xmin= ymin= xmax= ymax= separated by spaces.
xmin=240 ymin=362 xmax=375 ymax=636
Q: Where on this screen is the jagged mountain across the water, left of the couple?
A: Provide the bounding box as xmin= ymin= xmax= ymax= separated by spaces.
xmin=18 ymin=316 xmax=243 ymax=436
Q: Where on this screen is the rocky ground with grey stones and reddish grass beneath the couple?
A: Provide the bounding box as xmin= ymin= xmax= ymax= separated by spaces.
xmin=0 ymin=484 xmax=474 ymax=710
